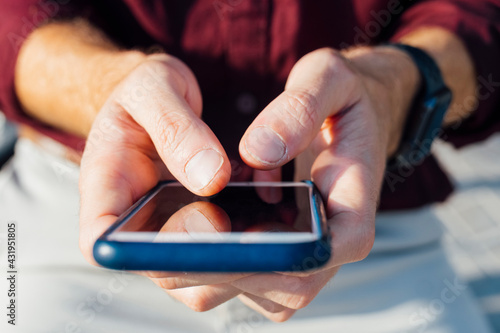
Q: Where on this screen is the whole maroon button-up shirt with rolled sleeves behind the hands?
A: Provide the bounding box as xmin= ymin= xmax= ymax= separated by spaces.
xmin=0 ymin=0 xmax=500 ymax=209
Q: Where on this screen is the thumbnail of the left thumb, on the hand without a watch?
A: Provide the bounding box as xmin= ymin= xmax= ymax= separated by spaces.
xmin=185 ymin=149 xmax=224 ymax=190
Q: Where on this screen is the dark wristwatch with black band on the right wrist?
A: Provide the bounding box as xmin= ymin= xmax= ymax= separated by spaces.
xmin=384 ymin=43 xmax=452 ymax=171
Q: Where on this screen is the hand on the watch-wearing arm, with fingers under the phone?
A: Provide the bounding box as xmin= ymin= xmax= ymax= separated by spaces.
xmin=149 ymin=47 xmax=419 ymax=321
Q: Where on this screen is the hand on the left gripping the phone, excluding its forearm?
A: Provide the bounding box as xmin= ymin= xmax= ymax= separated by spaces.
xmin=80 ymin=55 xmax=238 ymax=270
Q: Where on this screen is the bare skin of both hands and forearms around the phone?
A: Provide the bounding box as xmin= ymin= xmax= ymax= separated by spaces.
xmin=16 ymin=21 xmax=476 ymax=321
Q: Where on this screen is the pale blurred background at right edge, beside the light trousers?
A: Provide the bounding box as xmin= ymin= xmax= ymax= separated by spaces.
xmin=433 ymin=134 xmax=500 ymax=332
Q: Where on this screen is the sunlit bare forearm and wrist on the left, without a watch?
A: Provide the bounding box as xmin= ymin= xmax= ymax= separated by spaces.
xmin=14 ymin=21 xmax=143 ymax=136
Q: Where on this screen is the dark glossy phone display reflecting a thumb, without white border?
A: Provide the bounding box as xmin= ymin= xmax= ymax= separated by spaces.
xmin=116 ymin=184 xmax=312 ymax=233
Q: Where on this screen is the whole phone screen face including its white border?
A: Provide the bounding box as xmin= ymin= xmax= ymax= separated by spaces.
xmin=107 ymin=182 xmax=320 ymax=242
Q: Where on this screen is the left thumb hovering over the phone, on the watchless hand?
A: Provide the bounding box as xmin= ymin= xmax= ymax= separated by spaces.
xmin=116 ymin=56 xmax=231 ymax=195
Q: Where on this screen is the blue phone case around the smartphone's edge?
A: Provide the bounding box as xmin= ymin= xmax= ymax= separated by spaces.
xmin=93 ymin=181 xmax=331 ymax=272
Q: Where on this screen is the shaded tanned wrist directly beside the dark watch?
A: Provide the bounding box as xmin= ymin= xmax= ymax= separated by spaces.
xmin=344 ymin=46 xmax=421 ymax=157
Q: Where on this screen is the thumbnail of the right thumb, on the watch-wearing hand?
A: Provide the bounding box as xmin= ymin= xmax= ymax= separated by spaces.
xmin=245 ymin=126 xmax=286 ymax=164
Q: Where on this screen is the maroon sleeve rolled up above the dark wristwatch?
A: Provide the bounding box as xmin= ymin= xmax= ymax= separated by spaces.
xmin=391 ymin=0 xmax=500 ymax=147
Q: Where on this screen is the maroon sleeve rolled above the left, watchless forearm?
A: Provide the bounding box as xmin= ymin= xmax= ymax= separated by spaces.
xmin=0 ymin=0 xmax=85 ymax=150
